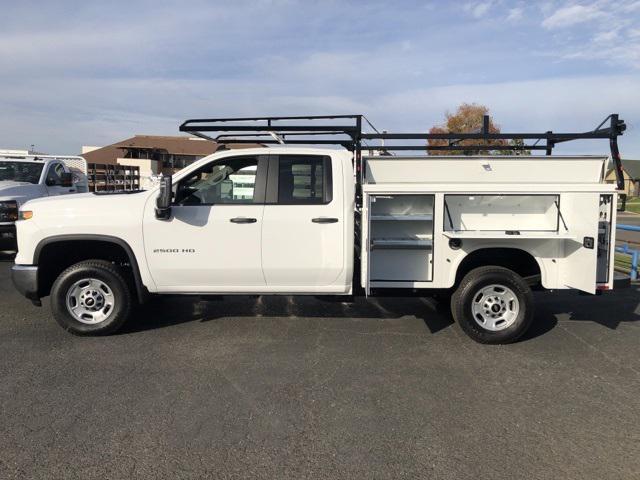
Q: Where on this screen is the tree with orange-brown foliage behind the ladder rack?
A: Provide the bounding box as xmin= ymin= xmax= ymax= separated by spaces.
xmin=428 ymin=103 xmax=531 ymax=155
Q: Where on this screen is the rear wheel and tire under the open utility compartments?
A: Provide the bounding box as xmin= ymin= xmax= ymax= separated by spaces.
xmin=451 ymin=266 xmax=533 ymax=344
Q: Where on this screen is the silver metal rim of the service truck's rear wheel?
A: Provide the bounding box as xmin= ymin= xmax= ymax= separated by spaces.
xmin=471 ymin=284 xmax=520 ymax=332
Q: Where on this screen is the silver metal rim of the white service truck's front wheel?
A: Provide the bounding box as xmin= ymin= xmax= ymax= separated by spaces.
xmin=67 ymin=278 xmax=115 ymax=325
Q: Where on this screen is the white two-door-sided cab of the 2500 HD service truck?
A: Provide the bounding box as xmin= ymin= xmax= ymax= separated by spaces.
xmin=142 ymin=148 xmax=355 ymax=294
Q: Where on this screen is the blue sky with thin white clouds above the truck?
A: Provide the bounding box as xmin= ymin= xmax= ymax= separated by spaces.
xmin=0 ymin=0 xmax=640 ymax=158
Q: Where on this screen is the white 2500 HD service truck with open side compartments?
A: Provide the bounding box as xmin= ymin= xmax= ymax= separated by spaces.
xmin=13 ymin=116 xmax=624 ymax=343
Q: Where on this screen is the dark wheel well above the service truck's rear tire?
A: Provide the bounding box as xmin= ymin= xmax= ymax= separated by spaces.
xmin=456 ymin=248 xmax=541 ymax=286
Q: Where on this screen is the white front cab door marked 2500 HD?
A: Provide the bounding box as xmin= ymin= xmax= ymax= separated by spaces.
xmin=144 ymin=155 xmax=268 ymax=293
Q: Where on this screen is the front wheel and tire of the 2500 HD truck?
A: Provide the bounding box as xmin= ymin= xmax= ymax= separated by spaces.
xmin=51 ymin=260 xmax=133 ymax=335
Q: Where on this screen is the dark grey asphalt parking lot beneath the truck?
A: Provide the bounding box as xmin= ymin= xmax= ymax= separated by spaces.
xmin=0 ymin=256 xmax=640 ymax=480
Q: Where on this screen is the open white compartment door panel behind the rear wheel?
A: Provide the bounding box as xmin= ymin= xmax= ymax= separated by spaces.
xmin=560 ymin=193 xmax=599 ymax=293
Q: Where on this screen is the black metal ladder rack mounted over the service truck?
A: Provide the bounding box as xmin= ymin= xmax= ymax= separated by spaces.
xmin=180 ymin=113 xmax=626 ymax=190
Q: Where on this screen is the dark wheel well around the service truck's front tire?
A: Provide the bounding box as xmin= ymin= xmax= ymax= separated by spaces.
xmin=35 ymin=239 xmax=142 ymax=299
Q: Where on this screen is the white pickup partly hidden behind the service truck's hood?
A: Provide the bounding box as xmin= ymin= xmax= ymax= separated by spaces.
xmin=0 ymin=154 xmax=87 ymax=250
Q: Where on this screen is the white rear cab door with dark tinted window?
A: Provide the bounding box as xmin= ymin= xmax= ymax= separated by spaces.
xmin=262 ymin=154 xmax=345 ymax=292
